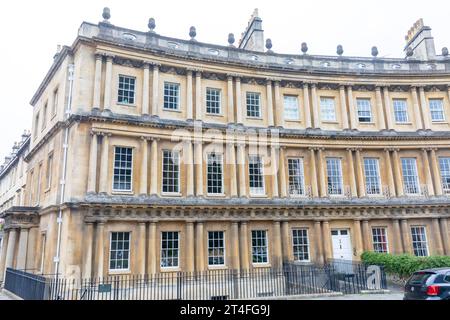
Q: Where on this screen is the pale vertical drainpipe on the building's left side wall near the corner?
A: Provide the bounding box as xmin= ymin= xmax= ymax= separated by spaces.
xmin=53 ymin=64 xmax=75 ymax=280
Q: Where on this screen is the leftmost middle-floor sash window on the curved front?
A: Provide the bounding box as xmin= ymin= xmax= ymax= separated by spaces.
xmin=113 ymin=147 xmax=133 ymax=191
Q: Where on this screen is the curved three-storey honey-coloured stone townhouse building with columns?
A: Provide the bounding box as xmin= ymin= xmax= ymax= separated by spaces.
xmin=1 ymin=9 xmax=450 ymax=277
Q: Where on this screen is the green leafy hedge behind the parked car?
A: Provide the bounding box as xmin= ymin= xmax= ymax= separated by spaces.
xmin=361 ymin=252 xmax=450 ymax=279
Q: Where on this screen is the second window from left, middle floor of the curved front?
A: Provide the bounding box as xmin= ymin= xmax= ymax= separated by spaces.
xmin=162 ymin=150 xmax=180 ymax=193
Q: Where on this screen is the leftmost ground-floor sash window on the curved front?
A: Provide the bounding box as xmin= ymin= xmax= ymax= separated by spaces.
xmin=109 ymin=232 xmax=131 ymax=271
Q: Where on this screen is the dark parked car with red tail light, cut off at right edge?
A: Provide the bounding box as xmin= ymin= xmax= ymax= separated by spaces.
xmin=403 ymin=268 xmax=450 ymax=300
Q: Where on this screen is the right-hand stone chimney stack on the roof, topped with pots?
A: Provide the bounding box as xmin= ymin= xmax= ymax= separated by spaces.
xmin=404 ymin=19 xmax=436 ymax=61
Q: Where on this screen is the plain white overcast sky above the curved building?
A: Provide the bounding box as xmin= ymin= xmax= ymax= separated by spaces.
xmin=0 ymin=0 xmax=450 ymax=160
